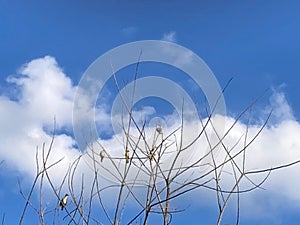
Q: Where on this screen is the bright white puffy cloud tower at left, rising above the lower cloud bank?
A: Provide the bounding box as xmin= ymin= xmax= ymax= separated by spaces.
xmin=8 ymin=56 xmax=74 ymax=128
